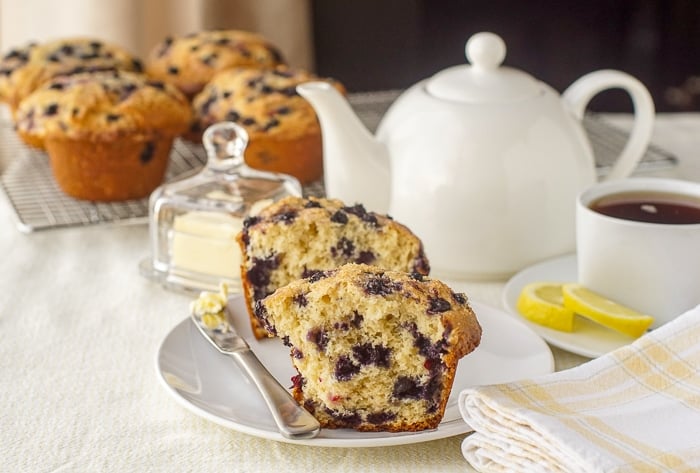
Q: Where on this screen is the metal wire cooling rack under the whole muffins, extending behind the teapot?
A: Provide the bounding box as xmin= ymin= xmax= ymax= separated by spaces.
xmin=0 ymin=90 xmax=677 ymax=233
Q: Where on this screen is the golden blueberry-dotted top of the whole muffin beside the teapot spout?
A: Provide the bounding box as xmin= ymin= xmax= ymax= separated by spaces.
xmin=193 ymin=66 xmax=345 ymax=140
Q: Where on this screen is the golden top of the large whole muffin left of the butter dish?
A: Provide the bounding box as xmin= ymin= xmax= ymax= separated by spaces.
xmin=16 ymin=71 xmax=191 ymax=139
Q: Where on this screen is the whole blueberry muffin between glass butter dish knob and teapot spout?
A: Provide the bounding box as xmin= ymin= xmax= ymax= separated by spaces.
xmin=193 ymin=66 xmax=345 ymax=184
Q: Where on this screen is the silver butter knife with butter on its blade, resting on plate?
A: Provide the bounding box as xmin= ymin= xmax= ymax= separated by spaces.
xmin=191 ymin=312 xmax=321 ymax=439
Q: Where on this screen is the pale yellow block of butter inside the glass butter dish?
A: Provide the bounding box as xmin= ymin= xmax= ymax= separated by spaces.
xmin=171 ymin=211 xmax=243 ymax=279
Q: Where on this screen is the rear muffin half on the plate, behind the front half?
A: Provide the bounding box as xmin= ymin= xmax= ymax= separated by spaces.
xmin=237 ymin=197 xmax=430 ymax=338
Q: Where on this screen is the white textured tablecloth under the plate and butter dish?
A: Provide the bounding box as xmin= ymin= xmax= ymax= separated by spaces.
xmin=0 ymin=114 xmax=700 ymax=473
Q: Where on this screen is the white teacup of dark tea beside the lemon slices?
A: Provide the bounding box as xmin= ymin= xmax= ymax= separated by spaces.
xmin=576 ymin=178 xmax=700 ymax=328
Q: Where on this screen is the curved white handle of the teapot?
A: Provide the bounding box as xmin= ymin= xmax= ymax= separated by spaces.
xmin=562 ymin=69 xmax=655 ymax=180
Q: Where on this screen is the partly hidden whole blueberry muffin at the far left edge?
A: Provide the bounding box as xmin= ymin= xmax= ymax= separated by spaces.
xmin=0 ymin=38 xmax=143 ymax=115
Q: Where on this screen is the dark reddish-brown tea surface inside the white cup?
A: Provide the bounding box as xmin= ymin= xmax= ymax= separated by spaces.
xmin=589 ymin=191 xmax=700 ymax=225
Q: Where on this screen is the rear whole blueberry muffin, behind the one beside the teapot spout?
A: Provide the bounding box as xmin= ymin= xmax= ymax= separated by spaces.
xmin=146 ymin=30 xmax=284 ymax=97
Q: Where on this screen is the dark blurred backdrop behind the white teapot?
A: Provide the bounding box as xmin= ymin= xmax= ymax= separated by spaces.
xmin=312 ymin=0 xmax=700 ymax=111
